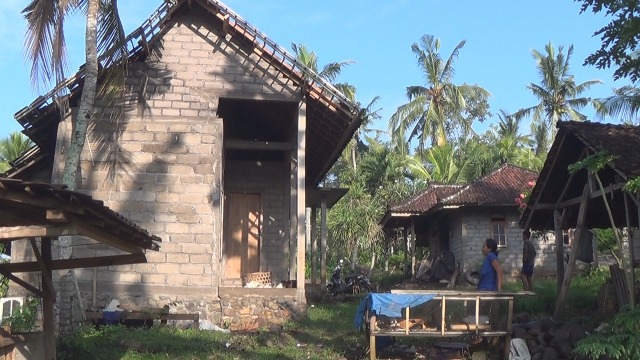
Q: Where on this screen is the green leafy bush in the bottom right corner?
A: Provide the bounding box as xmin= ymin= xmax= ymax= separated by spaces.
xmin=574 ymin=309 xmax=640 ymax=360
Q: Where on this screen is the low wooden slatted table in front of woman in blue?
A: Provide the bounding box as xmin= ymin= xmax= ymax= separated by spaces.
xmin=365 ymin=290 xmax=534 ymax=360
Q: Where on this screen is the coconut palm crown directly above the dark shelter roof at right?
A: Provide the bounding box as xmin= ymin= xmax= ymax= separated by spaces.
xmin=513 ymin=42 xmax=602 ymax=133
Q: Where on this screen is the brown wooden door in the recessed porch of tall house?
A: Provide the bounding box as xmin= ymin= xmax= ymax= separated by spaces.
xmin=225 ymin=193 xmax=261 ymax=279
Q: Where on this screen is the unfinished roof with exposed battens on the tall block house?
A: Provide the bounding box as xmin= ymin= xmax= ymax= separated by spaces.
xmin=8 ymin=0 xmax=363 ymax=186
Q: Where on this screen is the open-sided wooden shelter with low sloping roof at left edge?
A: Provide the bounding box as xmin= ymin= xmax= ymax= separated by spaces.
xmin=0 ymin=178 xmax=160 ymax=360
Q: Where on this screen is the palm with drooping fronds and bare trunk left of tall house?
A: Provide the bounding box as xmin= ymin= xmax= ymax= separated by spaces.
xmin=23 ymin=0 xmax=127 ymax=190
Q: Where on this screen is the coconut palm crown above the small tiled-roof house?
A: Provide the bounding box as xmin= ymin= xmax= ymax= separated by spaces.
xmin=389 ymin=35 xmax=489 ymax=151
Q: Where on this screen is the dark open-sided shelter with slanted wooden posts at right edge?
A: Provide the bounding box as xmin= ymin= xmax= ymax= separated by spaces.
xmin=520 ymin=121 xmax=640 ymax=310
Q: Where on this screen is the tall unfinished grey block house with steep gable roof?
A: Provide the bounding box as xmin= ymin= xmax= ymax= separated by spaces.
xmin=9 ymin=0 xmax=362 ymax=328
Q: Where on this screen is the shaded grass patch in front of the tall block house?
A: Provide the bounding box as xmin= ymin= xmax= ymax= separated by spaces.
xmin=58 ymin=301 xmax=365 ymax=360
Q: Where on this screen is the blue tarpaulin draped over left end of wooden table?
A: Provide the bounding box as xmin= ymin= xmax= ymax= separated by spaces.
xmin=354 ymin=293 xmax=436 ymax=329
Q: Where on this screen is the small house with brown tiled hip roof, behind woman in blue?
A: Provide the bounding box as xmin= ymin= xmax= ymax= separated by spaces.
xmin=381 ymin=164 xmax=555 ymax=276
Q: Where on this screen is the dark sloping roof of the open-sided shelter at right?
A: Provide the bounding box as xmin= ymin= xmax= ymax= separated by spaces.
xmin=520 ymin=121 xmax=640 ymax=230
